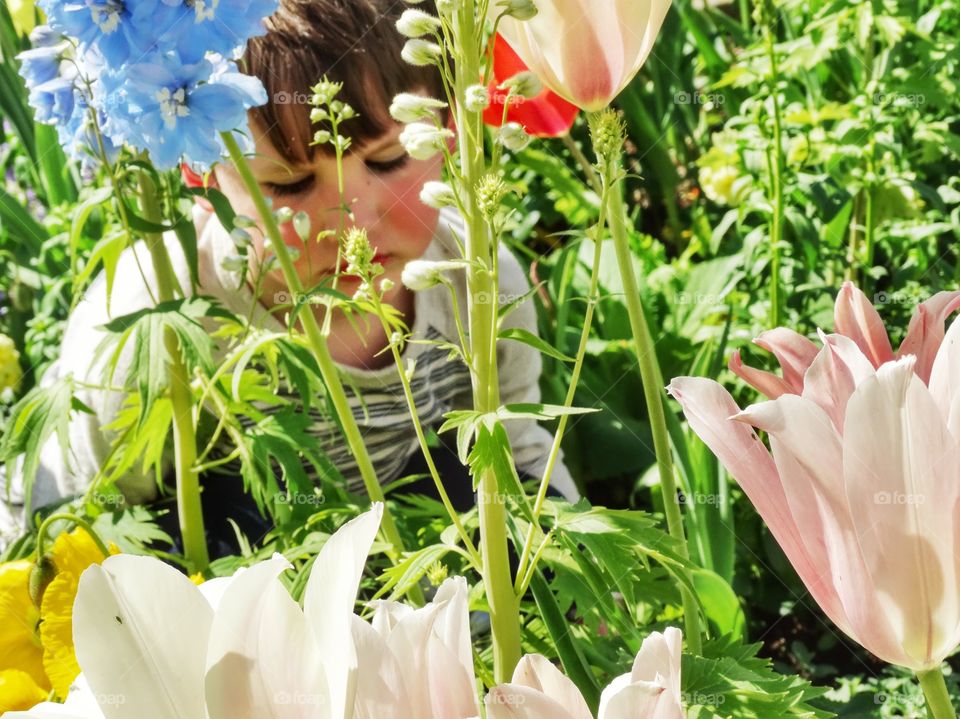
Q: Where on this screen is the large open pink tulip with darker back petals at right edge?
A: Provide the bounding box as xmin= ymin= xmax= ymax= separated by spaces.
xmin=669 ymin=283 xmax=960 ymax=672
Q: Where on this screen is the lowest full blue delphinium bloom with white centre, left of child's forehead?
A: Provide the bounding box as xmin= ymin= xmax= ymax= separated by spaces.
xmin=103 ymin=53 xmax=267 ymax=169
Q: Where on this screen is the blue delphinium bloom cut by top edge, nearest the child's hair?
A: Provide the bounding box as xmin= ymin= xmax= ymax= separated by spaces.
xmin=155 ymin=0 xmax=278 ymax=63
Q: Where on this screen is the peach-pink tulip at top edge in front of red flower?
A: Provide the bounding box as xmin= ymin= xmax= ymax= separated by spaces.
xmin=499 ymin=0 xmax=670 ymax=112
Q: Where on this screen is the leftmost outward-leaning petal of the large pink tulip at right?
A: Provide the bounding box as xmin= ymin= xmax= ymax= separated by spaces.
xmin=668 ymin=377 xmax=824 ymax=620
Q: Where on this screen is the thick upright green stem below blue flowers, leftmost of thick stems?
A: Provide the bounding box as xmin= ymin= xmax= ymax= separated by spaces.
xmin=140 ymin=170 xmax=210 ymax=573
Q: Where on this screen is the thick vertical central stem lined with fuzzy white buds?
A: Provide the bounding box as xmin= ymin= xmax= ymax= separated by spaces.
xmin=454 ymin=0 xmax=520 ymax=683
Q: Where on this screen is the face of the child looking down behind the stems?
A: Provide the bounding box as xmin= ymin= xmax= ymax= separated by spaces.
xmin=216 ymin=117 xmax=443 ymax=293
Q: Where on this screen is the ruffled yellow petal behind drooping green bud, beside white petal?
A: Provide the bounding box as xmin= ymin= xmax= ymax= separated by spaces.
xmin=40 ymin=528 xmax=119 ymax=699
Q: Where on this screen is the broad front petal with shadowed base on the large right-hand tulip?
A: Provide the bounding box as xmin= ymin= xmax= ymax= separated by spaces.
xmin=844 ymin=357 xmax=960 ymax=670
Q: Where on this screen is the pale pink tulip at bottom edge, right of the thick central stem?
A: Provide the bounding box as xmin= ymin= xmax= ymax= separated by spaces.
xmin=486 ymin=627 xmax=684 ymax=719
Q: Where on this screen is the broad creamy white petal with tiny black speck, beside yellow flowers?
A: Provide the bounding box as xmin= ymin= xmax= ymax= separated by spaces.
xmin=73 ymin=554 xmax=213 ymax=719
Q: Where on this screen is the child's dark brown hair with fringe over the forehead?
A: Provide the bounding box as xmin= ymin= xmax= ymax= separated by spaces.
xmin=245 ymin=0 xmax=443 ymax=163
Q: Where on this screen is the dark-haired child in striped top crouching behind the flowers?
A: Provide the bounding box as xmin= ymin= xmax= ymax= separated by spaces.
xmin=0 ymin=0 xmax=577 ymax=553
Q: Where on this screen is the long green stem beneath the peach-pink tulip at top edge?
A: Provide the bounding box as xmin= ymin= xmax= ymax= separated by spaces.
xmin=607 ymin=184 xmax=701 ymax=654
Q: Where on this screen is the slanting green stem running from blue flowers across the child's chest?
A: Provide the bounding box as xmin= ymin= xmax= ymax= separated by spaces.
xmin=221 ymin=132 xmax=422 ymax=603
